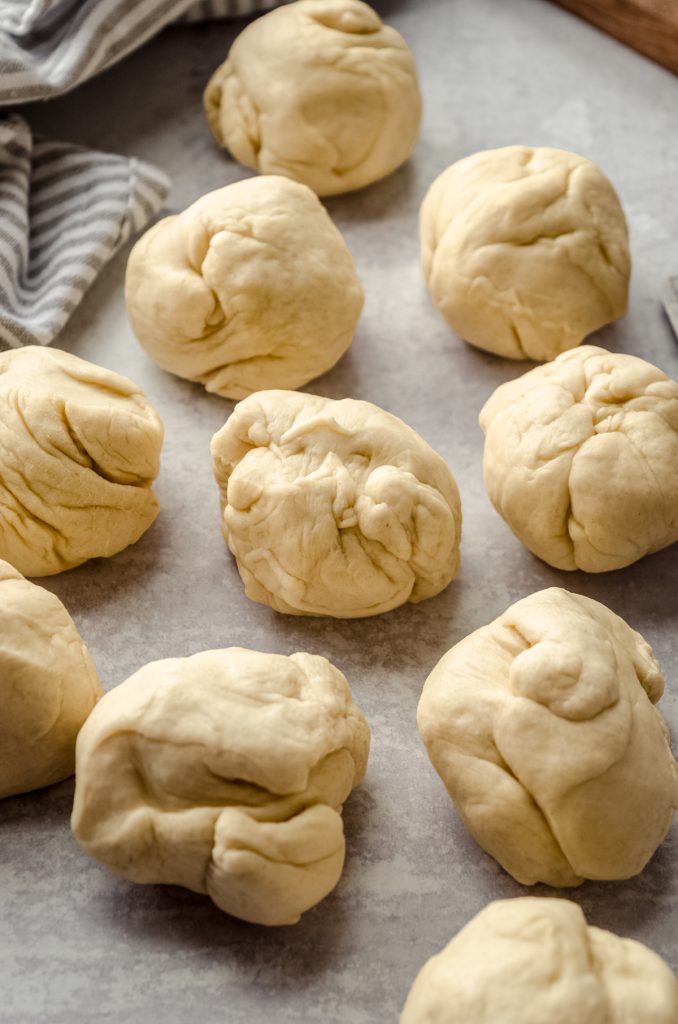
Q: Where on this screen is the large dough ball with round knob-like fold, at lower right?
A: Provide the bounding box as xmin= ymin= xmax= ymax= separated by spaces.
xmin=418 ymin=587 xmax=678 ymax=886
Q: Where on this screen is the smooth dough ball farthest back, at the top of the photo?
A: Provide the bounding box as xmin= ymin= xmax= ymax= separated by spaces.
xmin=205 ymin=0 xmax=421 ymax=196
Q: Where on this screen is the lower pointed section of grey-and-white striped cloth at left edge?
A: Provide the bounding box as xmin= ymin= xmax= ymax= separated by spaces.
xmin=0 ymin=115 xmax=169 ymax=349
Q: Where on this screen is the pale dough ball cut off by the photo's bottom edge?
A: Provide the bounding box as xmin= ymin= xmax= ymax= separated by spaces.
xmin=400 ymin=896 xmax=678 ymax=1024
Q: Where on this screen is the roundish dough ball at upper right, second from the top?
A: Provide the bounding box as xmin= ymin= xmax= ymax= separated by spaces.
xmin=421 ymin=145 xmax=631 ymax=359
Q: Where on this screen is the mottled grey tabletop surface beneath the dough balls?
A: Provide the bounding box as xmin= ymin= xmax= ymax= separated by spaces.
xmin=0 ymin=0 xmax=678 ymax=1024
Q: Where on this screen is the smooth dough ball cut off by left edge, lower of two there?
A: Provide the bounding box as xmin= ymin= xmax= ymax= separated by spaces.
xmin=0 ymin=561 xmax=103 ymax=798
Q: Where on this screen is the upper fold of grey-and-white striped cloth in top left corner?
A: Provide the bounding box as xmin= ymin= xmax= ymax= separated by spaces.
xmin=0 ymin=0 xmax=280 ymax=105
